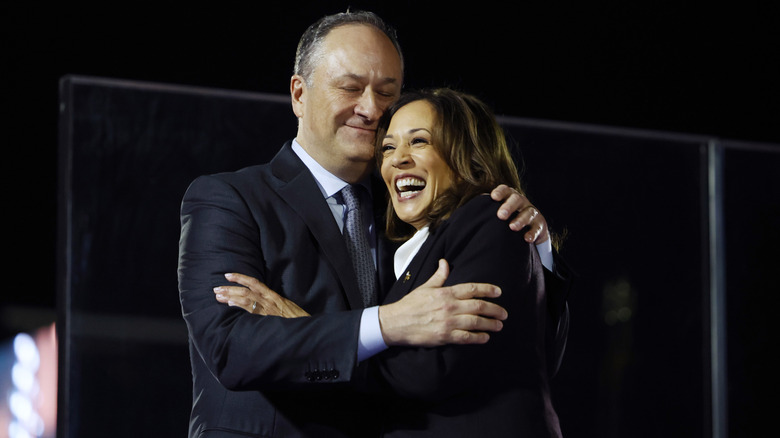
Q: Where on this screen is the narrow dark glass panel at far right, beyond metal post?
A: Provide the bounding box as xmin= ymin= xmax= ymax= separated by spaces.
xmin=724 ymin=143 xmax=780 ymax=436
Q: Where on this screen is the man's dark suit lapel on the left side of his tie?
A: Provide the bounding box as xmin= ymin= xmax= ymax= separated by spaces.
xmin=271 ymin=142 xmax=363 ymax=309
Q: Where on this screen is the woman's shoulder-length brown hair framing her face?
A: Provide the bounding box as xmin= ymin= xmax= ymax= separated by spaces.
xmin=376 ymin=88 xmax=522 ymax=240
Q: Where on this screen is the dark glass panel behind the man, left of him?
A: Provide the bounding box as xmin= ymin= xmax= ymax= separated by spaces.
xmin=58 ymin=77 xmax=297 ymax=437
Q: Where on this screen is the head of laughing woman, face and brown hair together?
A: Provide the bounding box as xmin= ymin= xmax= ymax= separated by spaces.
xmin=376 ymin=89 xmax=522 ymax=240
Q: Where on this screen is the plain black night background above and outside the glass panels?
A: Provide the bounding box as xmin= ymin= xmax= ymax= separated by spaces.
xmin=6 ymin=1 xmax=780 ymax=314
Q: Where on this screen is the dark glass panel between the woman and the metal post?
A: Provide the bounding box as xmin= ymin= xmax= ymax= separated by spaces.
xmin=505 ymin=119 xmax=708 ymax=437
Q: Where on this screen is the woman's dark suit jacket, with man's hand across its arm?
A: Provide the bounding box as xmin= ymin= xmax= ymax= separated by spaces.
xmin=372 ymin=196 xmax=560 ymax=437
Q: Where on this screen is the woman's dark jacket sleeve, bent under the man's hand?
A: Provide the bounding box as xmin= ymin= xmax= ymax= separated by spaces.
xmin=376 ymin=199 xmax=545 ymax=401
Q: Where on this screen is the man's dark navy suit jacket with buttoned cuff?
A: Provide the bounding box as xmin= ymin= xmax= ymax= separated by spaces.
xmin=179 ymin=143 xmax=394 ymax=437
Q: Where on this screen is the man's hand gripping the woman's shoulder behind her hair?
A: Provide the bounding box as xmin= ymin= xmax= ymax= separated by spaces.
xmin=490 ymin=184 xmax=550 ymax=245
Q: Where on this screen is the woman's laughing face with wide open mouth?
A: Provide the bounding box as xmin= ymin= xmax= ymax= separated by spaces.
xmin=381 ymin=100 xmax=453 ymax=230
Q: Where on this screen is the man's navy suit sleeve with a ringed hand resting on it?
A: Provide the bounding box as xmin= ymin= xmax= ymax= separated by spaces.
xmin=178 ymin=177 xmax=360 ymax=390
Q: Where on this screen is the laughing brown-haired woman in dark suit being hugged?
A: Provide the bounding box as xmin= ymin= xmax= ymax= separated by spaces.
xmin=219 ymin=89 xmax=560 ymax=437
